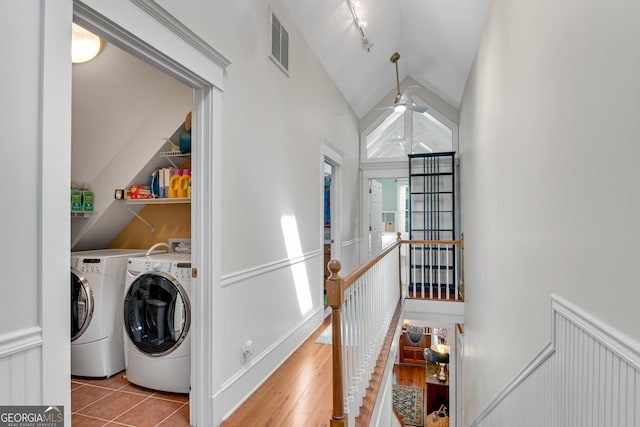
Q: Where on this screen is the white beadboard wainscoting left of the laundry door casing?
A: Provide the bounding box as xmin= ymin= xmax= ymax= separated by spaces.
xmin=0 ymin=327 xmax=42 ymax=405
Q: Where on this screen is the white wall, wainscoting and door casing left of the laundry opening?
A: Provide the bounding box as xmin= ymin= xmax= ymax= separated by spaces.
xmin=0 ymin=1 xmax=72 ymax=419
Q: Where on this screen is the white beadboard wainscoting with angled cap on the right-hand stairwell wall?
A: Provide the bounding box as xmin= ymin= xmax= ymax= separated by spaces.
xmin=471 ymin=296 xmax=640 ymax=427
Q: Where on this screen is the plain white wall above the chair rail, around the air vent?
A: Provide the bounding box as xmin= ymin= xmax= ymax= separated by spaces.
xmin=158 ymin=0 xmax=359 ymax=274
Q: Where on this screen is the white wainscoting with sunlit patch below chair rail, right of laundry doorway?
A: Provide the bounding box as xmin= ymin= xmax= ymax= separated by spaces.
xmin=213 ymin=250 xmax=324 ymax=422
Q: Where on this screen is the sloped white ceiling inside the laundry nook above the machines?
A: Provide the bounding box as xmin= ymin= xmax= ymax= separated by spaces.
xmin=71 ymin=43 xmax=192 ymax=251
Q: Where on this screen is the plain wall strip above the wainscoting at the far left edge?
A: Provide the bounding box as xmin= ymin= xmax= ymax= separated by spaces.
xmin=0 ymin=2 xmax=42 ymax=334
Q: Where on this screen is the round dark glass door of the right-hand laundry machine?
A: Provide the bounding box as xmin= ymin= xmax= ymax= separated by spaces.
xmin=124 ymin=272 xmax=191 ymax=356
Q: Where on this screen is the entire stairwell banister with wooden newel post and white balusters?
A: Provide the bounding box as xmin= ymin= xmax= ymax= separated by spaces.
xmin=326 ymin=233 xmax=464 ymax=427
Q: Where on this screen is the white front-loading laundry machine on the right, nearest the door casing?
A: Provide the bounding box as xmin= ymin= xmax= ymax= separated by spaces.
xmin=123 ymin=252 xmax=191 ymax=393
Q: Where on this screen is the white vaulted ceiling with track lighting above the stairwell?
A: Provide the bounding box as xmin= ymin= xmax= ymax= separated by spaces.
xmin=283 ymin=0 xmax=489 ymax=117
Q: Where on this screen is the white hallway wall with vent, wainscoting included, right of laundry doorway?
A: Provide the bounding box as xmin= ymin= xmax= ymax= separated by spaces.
xmin=149 ymin=0 xmax=359 ymax=417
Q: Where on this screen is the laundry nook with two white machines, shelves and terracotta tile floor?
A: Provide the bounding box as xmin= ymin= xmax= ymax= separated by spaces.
xmin=69 ymin=26 xmax=194 ymax=426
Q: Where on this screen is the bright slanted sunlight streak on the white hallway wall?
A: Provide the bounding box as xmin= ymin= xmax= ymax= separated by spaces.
xmin=280 ymin=215 xmax=313 ymax=315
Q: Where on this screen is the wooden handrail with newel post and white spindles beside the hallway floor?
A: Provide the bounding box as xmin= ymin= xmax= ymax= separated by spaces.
xmin=326 ymin=233 xmax=464 ymax=427
